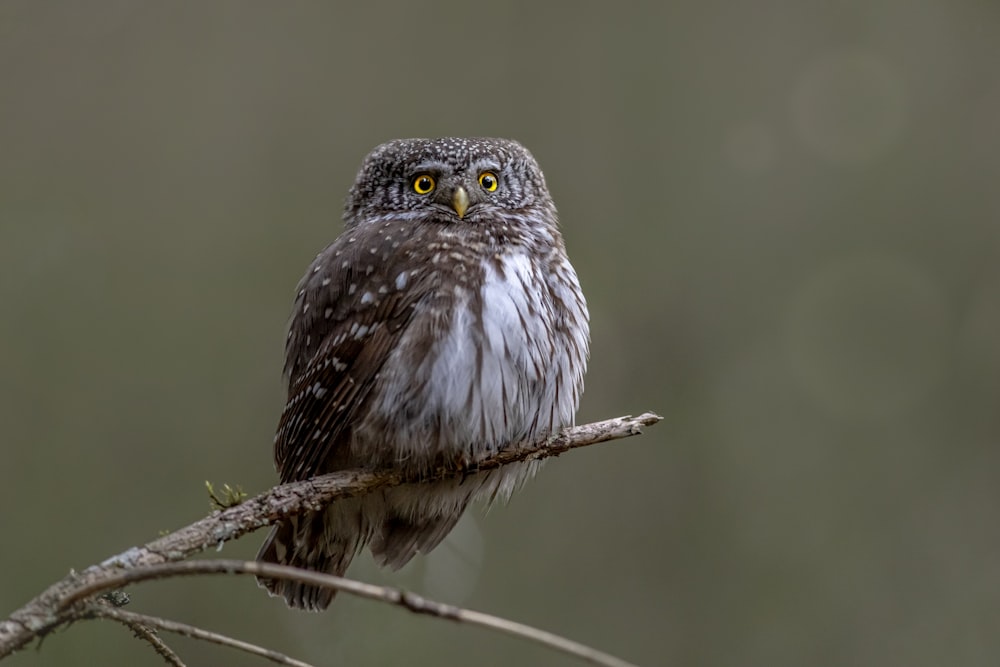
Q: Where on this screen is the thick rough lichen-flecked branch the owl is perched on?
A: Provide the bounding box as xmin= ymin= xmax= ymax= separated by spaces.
xmin=0 ymin=413 xmax=662 ymax=659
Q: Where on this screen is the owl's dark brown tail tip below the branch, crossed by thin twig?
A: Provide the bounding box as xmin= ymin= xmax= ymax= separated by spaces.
xmin=257 ymin=508 xmax=361 ymax=611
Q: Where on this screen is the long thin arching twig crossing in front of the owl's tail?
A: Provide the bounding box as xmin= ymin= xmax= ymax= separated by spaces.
xmin=64 ymin=559 xmax=635 ymax=667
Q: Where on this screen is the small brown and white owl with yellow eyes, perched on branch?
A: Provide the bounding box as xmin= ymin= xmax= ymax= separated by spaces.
xmin=258 ymin=138 xmax=589 ymax=610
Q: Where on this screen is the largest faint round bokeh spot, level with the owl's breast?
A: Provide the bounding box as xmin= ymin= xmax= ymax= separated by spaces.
xmin=787 ymin=256 xmax=950 ymax=417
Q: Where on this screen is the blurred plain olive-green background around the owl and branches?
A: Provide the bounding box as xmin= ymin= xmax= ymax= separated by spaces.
xmin=0 ymin=0 xmax=1000 ymax=667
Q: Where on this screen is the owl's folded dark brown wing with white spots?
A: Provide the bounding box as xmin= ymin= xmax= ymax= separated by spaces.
xmin=274 ymin=237 xmax=427 ymax=483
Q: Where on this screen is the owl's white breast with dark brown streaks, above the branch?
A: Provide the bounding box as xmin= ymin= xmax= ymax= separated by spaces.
xmin=355 ymin=248 xmax=587 ymax=466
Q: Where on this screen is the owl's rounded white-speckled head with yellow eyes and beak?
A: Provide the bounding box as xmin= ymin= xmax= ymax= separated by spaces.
xmin=344 ymin=137 xmax=555 ymax=227
